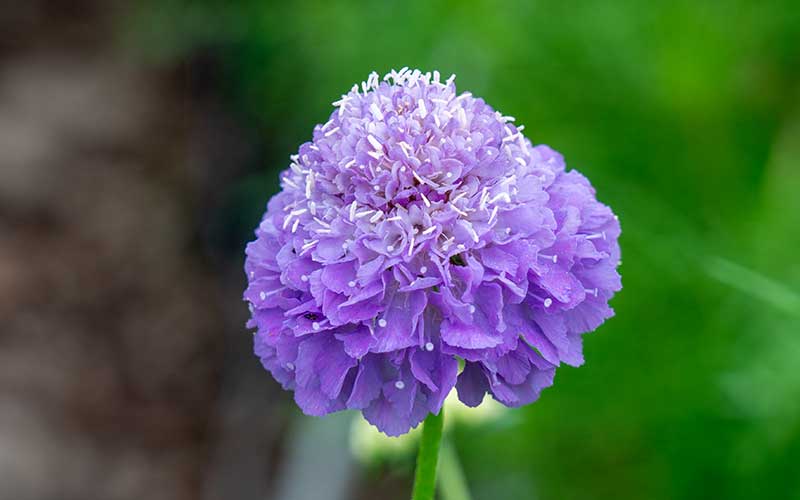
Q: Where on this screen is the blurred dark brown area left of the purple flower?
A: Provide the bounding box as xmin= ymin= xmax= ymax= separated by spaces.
xmin=0 ymin=0 xmax=282 ymax=500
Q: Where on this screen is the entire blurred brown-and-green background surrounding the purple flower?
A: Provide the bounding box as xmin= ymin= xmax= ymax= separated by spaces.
xmin=0 ymin=0 xmax=800 ymax=500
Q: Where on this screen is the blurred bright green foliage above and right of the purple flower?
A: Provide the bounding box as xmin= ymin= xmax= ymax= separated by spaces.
xmin=130 ymin=0 xmax=800 ymax=499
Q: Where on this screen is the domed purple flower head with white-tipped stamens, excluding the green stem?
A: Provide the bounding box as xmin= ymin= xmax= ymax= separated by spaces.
xmin=244 ymin=69 xmax=621 ymax=436
